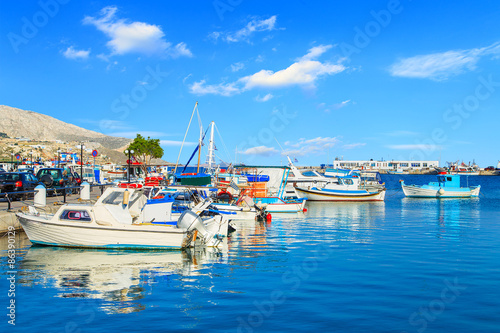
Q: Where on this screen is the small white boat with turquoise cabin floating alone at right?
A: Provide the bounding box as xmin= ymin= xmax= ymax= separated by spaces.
xmin=400 ymin=172 xmax=481 ymax=198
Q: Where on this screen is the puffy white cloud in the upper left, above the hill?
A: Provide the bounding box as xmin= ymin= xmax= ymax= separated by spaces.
xmin=83 ymin=6 xmax=192 ymax=58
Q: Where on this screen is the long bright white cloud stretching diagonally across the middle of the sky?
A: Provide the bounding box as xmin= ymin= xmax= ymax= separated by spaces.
xmin=191 ymin=45 xmax=346 ymax=96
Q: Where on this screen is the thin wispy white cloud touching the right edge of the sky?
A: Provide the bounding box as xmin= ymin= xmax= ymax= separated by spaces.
xmin=389 ymin=43 xmax=500 ymax=81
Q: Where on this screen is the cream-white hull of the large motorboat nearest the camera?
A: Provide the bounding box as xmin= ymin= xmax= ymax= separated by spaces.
xmin=17 ymin=213 xmax=190 ymax=249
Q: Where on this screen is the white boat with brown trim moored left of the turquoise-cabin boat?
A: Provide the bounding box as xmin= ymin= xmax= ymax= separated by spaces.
xmin=295 ymin=176 xmax=386 ymax=201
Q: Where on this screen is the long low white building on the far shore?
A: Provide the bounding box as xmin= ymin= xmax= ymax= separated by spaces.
xmin=333 ymin=160 xmax=439 ymax=170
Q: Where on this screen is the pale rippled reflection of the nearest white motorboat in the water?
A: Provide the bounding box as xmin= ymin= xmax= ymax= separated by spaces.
xmin=19 ymin=243 xmax=228 ymax=314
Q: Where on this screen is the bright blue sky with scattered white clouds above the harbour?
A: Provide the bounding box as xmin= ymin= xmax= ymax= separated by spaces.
xmin=0 ymin=0 xmax=500 ymax=166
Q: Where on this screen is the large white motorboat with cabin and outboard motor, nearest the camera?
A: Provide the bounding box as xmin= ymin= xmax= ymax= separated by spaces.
xmin=16 ymin=188 xmax=228 ymax=249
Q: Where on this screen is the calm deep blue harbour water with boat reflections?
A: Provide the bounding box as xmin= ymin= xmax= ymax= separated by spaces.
xmin=0 ymin=175 xmax=500 ymax=333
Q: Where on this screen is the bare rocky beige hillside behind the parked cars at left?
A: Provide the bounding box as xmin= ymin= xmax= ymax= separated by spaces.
xmin=0 ymin=105 xmax=131 ymax=149
